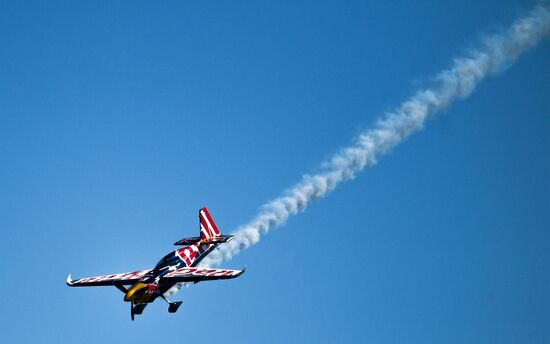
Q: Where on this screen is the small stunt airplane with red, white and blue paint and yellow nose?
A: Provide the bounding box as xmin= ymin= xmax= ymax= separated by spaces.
xmin=67 ymin=207 xmax=245 ymax=321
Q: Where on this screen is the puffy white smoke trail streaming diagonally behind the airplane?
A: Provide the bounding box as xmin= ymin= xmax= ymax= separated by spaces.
xmin=168 ymin=4 xmax=550 ymax=280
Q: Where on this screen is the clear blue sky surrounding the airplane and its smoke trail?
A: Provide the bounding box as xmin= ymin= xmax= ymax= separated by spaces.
xmin=0 ymin=0 xmax=550 ymax=343
